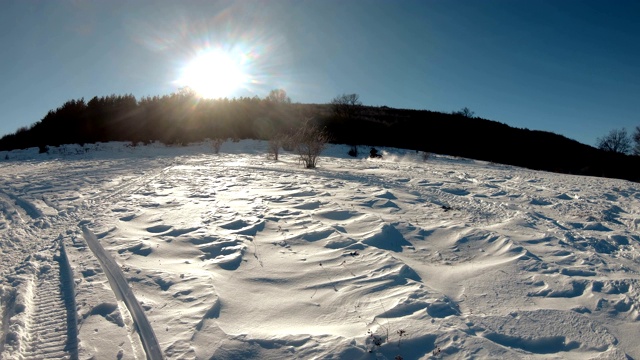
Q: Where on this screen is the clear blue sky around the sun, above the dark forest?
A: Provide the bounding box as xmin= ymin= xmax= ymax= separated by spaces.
xmin=0 ymin=0 xmax=640 ymax=145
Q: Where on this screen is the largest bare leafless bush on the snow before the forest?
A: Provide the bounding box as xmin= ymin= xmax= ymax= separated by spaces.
xmin=291 ymin=118 xmax=329 ymax=169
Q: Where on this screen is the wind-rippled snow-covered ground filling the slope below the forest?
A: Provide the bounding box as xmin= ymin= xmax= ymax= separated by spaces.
xmin=0 ymin=141 xmax=640 ymax=360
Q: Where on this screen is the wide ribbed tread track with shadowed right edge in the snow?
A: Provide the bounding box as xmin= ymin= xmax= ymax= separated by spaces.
xmin=20 ymin=248 xmax=78 ymax=360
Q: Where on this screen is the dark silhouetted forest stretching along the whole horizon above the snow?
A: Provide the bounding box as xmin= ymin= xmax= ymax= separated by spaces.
xmin=0 ymin=91 xmax=640 ymax=181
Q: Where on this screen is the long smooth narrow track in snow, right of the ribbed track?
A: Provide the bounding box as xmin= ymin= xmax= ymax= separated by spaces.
xmin=82 ymin=226 xmax=163 ymax=360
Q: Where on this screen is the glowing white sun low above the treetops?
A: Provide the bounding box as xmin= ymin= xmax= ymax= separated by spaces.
xmin=178 ymin=50 xmax=248 ymax=99
